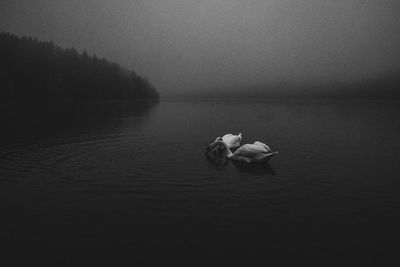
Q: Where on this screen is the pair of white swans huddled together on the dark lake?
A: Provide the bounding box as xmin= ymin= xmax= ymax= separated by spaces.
xmin=206 ymin=133 xmax=278 ymax=163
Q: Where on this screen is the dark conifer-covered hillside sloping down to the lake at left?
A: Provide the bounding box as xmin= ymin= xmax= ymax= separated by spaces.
xmin=0 ymin=33 xmax=159 ymax=100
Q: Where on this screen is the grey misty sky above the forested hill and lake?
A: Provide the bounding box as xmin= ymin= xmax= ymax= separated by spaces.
xmin=0 ymin=0 xmax=400 ymax=95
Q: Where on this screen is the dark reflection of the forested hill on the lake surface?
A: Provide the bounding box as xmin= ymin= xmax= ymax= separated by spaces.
xmin=0 ymin=101 xmax=157 ymax=144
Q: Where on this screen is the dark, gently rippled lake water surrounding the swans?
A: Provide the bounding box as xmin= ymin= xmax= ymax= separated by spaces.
xmin=0 ymin=101 xmax=400 ymax=266
